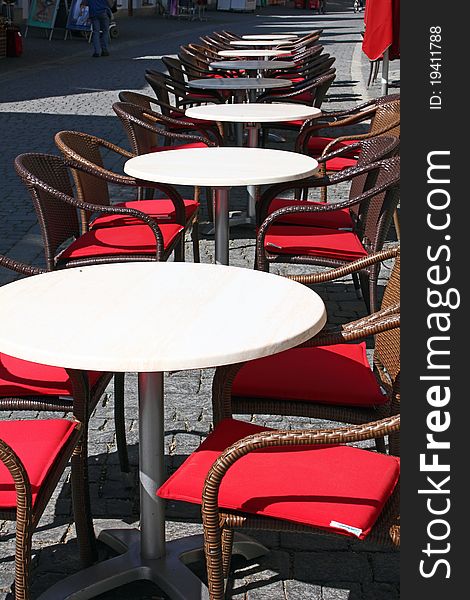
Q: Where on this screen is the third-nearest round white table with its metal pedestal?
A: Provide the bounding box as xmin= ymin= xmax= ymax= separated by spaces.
xmin=186 ymin=102 xmax=321 ymax=225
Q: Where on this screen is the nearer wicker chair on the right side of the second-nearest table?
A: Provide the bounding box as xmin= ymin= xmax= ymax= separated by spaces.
xmin=256 ymin=156 xmax=400 ymax=312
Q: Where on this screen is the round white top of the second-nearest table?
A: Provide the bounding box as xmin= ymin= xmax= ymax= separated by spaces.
xmin=124 ymin=146 xmax=318 ymax=187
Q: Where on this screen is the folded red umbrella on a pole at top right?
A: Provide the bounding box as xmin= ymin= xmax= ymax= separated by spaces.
xmin=362 ymin=0 xmax=400 ymax=93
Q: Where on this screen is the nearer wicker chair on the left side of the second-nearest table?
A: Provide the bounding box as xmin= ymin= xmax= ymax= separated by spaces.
xmin=15 ymin=153 xmax=185 ymax=271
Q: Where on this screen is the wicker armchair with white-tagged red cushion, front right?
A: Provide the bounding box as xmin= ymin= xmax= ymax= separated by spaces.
xmin=157 ymin=415 xmax=400 ymax=600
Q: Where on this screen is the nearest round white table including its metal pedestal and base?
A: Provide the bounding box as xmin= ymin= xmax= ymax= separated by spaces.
xmin=0 ymin=262 xmax=326 ymax=600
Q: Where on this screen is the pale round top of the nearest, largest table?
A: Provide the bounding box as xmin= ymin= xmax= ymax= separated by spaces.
xmin=0 ymin=264 xmax=326 ymax=372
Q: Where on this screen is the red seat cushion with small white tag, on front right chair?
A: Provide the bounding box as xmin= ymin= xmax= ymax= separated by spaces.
xmin=157 ymin=419 xmax=400 ymax=539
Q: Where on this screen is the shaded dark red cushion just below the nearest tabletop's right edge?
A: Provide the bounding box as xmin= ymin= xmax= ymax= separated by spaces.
xmin=232 ymin=342 xmax=388 ymax=407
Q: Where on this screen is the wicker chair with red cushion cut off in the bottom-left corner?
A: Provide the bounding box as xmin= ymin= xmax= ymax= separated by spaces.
xmin=0 ymin=419 xmax=85 ymax=600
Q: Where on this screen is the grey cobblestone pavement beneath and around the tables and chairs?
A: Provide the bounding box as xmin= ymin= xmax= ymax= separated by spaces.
xmin=0 ymin=0 xmax=399 ymax=600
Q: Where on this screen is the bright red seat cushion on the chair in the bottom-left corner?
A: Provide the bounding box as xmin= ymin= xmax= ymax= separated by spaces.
xmin=0 ymin=419 xmax=77 ymax=509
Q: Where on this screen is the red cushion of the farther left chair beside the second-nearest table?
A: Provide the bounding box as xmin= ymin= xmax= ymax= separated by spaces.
xmin=92 ymin=199 xmax=199 ymax=228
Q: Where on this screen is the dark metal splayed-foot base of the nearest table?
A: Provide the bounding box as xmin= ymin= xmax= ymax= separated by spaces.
xmin=38 ymin=529 xmax=268 ymax=600
